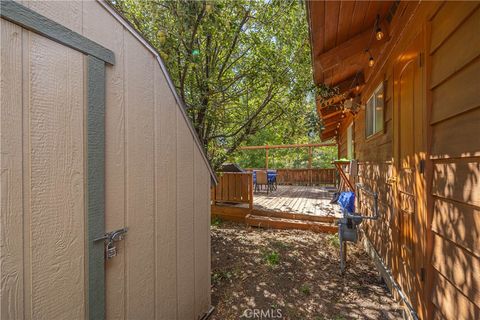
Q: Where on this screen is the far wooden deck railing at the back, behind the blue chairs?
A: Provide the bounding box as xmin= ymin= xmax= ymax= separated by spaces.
xmin=248 ymin=168 xmax=336 ymax=186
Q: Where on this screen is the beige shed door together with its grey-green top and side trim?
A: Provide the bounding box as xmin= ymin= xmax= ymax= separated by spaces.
xmin=0 ymin=1 xmax=110 ymax=319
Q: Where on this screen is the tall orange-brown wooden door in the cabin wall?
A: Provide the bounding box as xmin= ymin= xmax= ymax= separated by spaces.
xmin=394 ymin=30 xmax=425 ymax=318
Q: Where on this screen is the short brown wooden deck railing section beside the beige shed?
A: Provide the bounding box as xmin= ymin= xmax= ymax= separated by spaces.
xmin=212 ymin=172 xmax=253 ymax=209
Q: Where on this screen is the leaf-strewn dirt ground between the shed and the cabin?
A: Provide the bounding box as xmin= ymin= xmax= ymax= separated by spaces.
xmin=210 ymin=221 xmax=401 ymax=320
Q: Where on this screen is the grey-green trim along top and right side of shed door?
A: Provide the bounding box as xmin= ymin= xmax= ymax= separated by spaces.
xmin=0 ymin=0 xmax=115 ymax=320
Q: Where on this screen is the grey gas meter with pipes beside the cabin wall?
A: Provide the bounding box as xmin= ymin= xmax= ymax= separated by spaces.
xmin=338 ymin=183 xmax=378 ymax=273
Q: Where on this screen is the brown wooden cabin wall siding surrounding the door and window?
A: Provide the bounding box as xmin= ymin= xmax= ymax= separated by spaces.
xmin=338 ymin=2 xmax=480 ymax=319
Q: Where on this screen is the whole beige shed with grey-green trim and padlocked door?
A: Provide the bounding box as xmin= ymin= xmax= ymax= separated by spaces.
xmin=0 ymin=0 xmax=215 ymax=320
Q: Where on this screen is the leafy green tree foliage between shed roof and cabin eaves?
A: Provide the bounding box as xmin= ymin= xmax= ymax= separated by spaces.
xmin=110 ymin=0 xmax=318 ymax=167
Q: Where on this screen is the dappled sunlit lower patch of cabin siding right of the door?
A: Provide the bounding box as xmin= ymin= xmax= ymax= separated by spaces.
xmin=431 ymin=155 xmax=480 ymax=319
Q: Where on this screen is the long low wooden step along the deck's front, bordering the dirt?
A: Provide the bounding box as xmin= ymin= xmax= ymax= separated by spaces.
xmin=245 ymin=214 xmax=338 ymax=234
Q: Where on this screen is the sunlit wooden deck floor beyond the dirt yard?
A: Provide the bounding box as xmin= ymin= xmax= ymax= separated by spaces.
xmin=253 ymin=186 xmax=341 ymax=217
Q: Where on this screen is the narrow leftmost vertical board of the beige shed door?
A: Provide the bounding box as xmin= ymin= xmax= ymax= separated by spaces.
xmin=0 ymin=19 xmax=24 ymax=319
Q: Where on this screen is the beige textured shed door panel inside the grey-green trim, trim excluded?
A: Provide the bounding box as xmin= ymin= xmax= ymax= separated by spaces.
xmin=0 ymin=19 xmax=87 ymax=319
